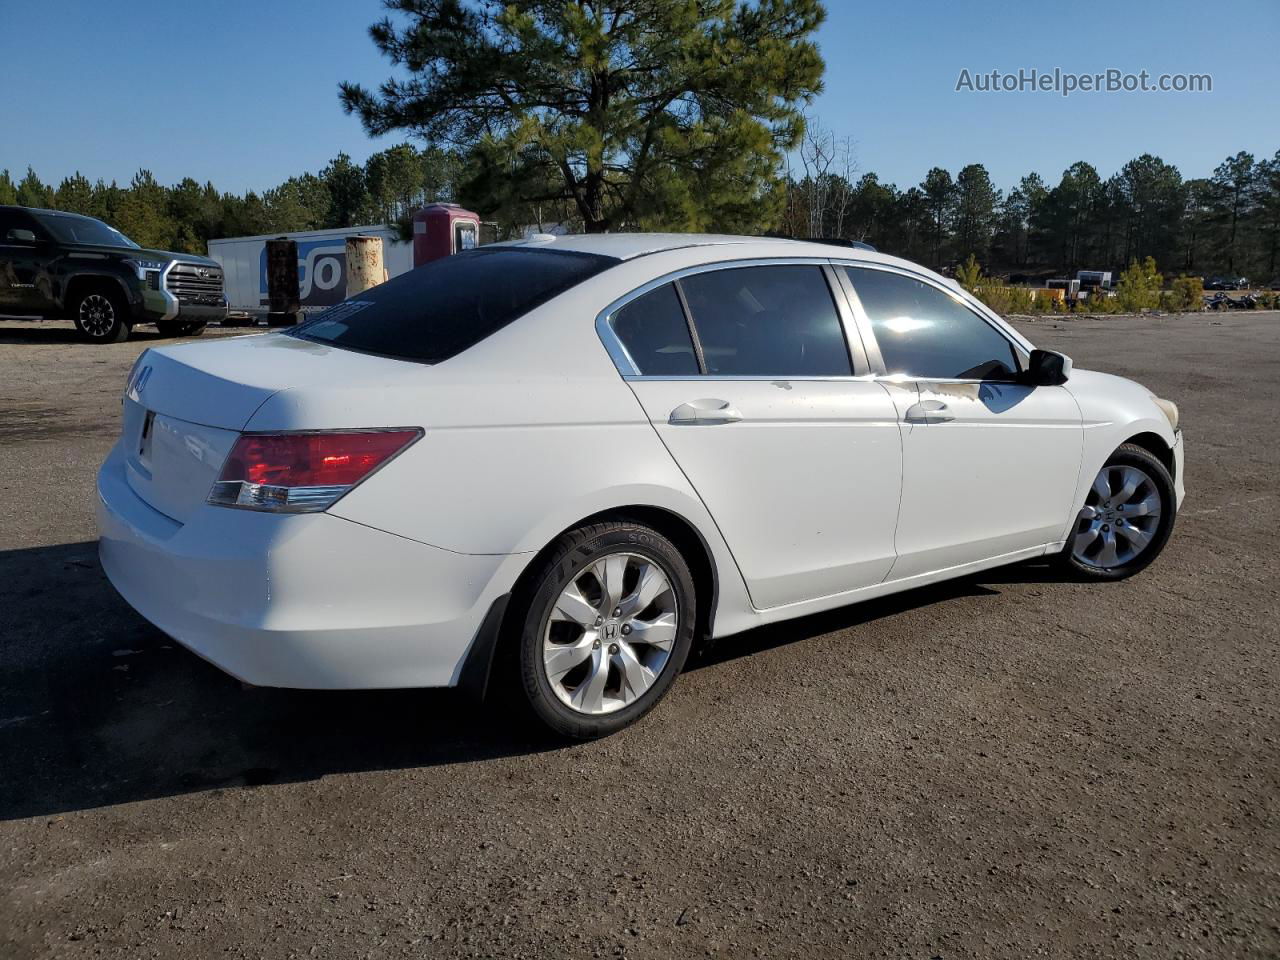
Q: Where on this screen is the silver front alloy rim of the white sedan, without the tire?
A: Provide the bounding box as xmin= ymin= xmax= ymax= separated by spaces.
xmin=1071 ymin=465 xmax=1164 ymax=570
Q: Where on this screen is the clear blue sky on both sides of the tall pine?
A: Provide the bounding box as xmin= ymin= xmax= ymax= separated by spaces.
xmin=0 ymin=0 xmax=1280 ymax=191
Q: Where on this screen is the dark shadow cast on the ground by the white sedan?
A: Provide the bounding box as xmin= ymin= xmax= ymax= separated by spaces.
xmin=0 ymin=541 xmax=1049 ymax=819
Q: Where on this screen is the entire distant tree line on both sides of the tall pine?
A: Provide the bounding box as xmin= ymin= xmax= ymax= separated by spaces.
xmin=0 ymin=140 xmax=1280 ymax=282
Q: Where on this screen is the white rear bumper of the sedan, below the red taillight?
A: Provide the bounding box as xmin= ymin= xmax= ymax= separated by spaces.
xmin=97 ymin=447 xmax=524 ymax=690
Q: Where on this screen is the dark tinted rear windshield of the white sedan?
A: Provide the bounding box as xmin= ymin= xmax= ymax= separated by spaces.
xmin=291 ymin=247 xmax=618 ymax=364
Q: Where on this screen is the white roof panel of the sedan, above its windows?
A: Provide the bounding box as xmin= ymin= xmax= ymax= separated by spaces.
xmin=490 ymin=233 xmax=897 ymax=262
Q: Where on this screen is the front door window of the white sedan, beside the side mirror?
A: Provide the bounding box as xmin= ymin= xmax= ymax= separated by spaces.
xmin=845 ymin=268 xmax=1019 ymax=380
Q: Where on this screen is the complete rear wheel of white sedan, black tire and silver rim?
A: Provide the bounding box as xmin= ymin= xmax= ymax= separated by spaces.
xmin=515 ymin=521 xmax=696 ymax=740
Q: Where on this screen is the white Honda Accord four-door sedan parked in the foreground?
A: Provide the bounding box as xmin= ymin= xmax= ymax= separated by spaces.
xmin=97 ymin=234 xmax=1183 ymax=737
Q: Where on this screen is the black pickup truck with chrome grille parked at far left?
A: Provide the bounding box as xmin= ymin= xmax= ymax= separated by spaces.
xmin=0 ymin=206 xmax=227 ymax=343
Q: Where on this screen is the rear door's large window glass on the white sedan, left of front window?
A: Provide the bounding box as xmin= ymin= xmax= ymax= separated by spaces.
xmin=680 ymin=264 xmax=854 ymax=378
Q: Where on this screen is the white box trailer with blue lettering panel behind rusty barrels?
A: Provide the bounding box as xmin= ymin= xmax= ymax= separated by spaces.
xmin=209 ymin=224 xmax=413 ymax=315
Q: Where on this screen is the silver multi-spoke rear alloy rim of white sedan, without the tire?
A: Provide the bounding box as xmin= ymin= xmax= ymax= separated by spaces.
xmin=543 ymin=553 xmax=680 ymax=716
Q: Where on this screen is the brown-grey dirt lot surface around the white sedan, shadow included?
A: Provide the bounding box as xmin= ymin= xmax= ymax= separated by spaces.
xmin=0 ymin=314 xmax=1280 ymax=960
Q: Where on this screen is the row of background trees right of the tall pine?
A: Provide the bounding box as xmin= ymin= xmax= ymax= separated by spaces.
xmin=782 ymin=127 xmax=1280 ymax=282
